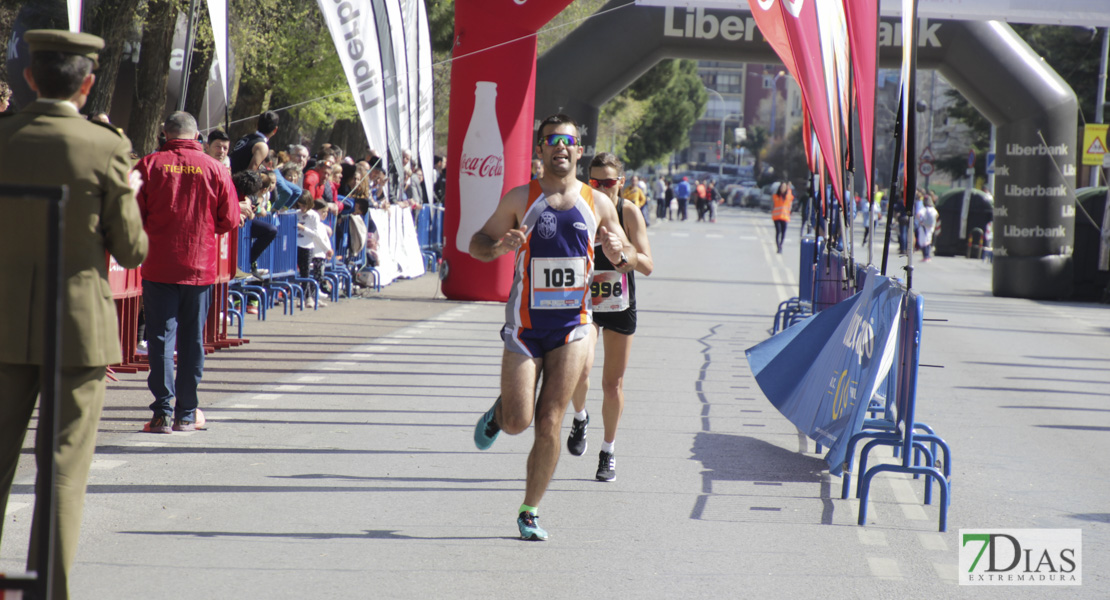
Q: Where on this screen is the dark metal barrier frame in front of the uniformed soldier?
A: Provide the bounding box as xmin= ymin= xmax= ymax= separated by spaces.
xmin=0 ymin=185 xmax=69 ymax=600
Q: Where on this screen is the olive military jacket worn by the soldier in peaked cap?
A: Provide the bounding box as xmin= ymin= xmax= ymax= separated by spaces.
xmin=0 ymin=102 xmax=148 ymax=366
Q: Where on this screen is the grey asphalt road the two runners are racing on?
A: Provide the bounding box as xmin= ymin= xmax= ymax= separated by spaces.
xmin=0 ymin=207 xmax=1110 ymax=600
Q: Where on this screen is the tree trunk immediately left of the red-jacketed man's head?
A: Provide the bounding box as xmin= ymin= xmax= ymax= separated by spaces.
xmin=128 ymin=0 xmax=181 ymax=156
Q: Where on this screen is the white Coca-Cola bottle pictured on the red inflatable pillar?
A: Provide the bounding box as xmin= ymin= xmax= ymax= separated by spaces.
xmin=455 ymin=81 xmax=505 ymax=253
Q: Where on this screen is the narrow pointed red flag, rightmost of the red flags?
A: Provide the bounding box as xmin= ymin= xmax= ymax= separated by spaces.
xmin=844 ymin=0 xmax=879 ymax=199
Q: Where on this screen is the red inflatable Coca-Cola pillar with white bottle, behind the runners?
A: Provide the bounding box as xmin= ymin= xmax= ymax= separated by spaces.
xmin=443 ymin=0 xmax=572 ymax=302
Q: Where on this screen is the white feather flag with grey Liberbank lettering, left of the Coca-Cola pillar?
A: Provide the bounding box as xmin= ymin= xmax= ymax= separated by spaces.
xmin=316 ymin=0 xmax=389 ymax=177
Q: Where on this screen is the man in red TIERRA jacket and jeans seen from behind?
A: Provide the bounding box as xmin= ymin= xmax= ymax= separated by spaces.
xmin=135 ymin=112 xmax=239 ymax=434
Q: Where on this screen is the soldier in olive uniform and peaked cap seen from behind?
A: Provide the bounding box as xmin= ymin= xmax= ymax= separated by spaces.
xmin=0 ymin=30 xmax=147 ymax=599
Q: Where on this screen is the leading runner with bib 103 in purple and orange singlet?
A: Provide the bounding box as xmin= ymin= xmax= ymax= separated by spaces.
xmin=470 ymin=114 xmax=638 ymax=540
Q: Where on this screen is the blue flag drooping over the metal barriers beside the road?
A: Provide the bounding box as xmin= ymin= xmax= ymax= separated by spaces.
xmin=746 ymin=267 xmax=904 ymax=475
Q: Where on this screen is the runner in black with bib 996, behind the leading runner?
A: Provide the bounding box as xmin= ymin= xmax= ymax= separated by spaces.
xmin=566 ymin=152 xmax=653 ymax=481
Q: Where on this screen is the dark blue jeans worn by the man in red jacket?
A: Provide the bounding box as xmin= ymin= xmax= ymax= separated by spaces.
xmin=142 ymin=281 xmax=212 ymax=421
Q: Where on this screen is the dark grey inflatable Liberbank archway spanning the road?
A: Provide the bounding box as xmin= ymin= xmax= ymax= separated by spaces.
xmin=536 ymin=2 xmax=1079 ymax=298
